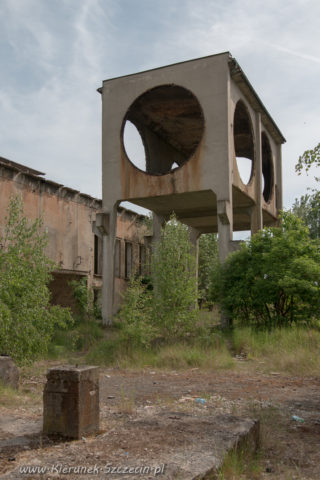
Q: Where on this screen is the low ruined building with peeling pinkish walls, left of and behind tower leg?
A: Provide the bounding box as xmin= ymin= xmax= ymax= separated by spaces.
xmin=0 ymin=157 xmax=145 ymax=308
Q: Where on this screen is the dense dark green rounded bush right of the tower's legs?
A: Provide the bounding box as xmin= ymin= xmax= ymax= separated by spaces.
xmin=211 ymin=213 xmax=320 ymax=328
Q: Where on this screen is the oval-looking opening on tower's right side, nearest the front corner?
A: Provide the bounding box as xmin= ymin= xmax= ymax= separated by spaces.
xmin=233 ymin=100 xmax=254 ymax=185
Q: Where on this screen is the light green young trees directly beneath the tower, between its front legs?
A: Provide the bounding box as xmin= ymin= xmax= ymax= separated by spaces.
xmin=118 ymin=216 xmax=197 ymax=347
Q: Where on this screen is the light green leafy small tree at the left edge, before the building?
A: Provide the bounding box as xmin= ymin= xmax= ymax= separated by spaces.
xmin=0 ymin=197 xmax=71 ymax=364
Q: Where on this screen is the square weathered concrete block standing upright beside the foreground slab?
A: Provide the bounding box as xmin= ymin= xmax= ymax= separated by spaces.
xmin=43 ymin=366 xmax=99 ymax=439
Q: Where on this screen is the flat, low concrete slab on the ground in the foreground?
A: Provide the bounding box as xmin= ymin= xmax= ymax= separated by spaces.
xmin=0 ymin=407 xmax=259 ymax=480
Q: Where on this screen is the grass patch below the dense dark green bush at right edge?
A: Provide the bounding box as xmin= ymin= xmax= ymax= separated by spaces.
xmin=232 ymin=327 xmax=320 ymax=375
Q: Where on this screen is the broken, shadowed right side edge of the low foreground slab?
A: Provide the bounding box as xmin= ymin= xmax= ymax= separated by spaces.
xmin=192 ymin=418 xmax=260 ymax=480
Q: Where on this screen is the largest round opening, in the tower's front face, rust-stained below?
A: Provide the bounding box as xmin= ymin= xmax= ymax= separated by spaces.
xmin=122 ymin=85 xmax=204 ymax=175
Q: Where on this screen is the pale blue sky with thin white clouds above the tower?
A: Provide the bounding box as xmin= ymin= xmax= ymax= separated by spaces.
xmin=0 ymin=0 xmax=320 ymax=214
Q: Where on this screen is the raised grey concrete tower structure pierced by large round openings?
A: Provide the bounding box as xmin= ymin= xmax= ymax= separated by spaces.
xmin=99 ymin=52 xmax=285 ymax=323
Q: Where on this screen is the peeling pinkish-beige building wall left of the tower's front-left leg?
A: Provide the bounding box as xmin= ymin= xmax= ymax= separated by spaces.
xmin=0 ymin=159 xmax=101 ymax=306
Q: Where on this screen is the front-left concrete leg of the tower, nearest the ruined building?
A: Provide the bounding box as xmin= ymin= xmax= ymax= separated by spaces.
xmin=95 ymin=204 xmax=118 ymax=325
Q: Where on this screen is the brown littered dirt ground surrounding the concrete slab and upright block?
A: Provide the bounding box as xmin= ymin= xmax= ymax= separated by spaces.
xmin=0 ymin=359 xmax=320 ymax=480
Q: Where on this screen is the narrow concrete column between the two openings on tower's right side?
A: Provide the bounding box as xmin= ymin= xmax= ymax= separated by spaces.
xmin=250 ymin=112 xmax=263 ymax=235
